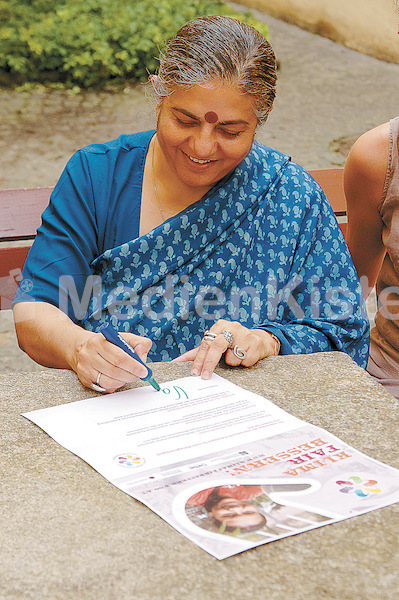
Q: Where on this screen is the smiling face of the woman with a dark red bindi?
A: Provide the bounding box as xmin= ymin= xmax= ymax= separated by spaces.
xmin=157 ymin=84 xmax=257 ymax=193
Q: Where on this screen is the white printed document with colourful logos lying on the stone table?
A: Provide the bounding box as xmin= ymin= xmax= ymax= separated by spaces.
xmin=23 ymin=375 xmax=399 ymax=559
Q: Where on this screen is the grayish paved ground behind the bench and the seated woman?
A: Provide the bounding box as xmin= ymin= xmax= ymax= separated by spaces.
xmin=0 ymin=11 xmax=399 ymax=373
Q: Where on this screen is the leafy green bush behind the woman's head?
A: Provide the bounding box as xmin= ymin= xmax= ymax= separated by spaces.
xmin=0 ymin=0 xmax=267 ymax=88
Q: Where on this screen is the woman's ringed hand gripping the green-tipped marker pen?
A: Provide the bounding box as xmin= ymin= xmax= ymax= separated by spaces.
xmin=75 ymin=333 xmax=151 ymax=392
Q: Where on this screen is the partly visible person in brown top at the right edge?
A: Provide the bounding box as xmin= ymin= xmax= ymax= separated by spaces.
xmin=344 ymin=117 xmax=399 ymax=398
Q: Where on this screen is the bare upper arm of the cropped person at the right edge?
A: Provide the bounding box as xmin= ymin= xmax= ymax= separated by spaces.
xmin=344 ymin=123 xmax=389 ymax=297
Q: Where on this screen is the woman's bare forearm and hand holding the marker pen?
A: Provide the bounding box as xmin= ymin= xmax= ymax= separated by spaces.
xmin=13 ymin=302 xmax=151 ymax=391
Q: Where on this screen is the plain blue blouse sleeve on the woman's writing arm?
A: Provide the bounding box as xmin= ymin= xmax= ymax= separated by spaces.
xmin=14 ymin=136 xmax=145 ymax=323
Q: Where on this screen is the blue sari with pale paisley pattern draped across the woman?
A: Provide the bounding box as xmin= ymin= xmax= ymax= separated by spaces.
xmin=82 ymin=142 xmax=368 ymax=367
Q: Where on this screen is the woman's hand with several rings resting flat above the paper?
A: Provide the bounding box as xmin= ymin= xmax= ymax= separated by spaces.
xmin=174 ymin=319 xmax=276 ymax=379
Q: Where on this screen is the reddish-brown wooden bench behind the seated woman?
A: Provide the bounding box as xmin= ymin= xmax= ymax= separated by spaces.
xmin=0 ymin=168 xmax=346 ymax=309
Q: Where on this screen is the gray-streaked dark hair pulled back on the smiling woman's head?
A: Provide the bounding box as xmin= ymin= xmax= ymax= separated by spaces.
xmin=153 ymin=16 xmax=277 ymax=125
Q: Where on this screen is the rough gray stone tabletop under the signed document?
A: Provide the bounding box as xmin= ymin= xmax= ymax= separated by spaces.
xmin=0 ymin=352 xmax=399 ymax=600
